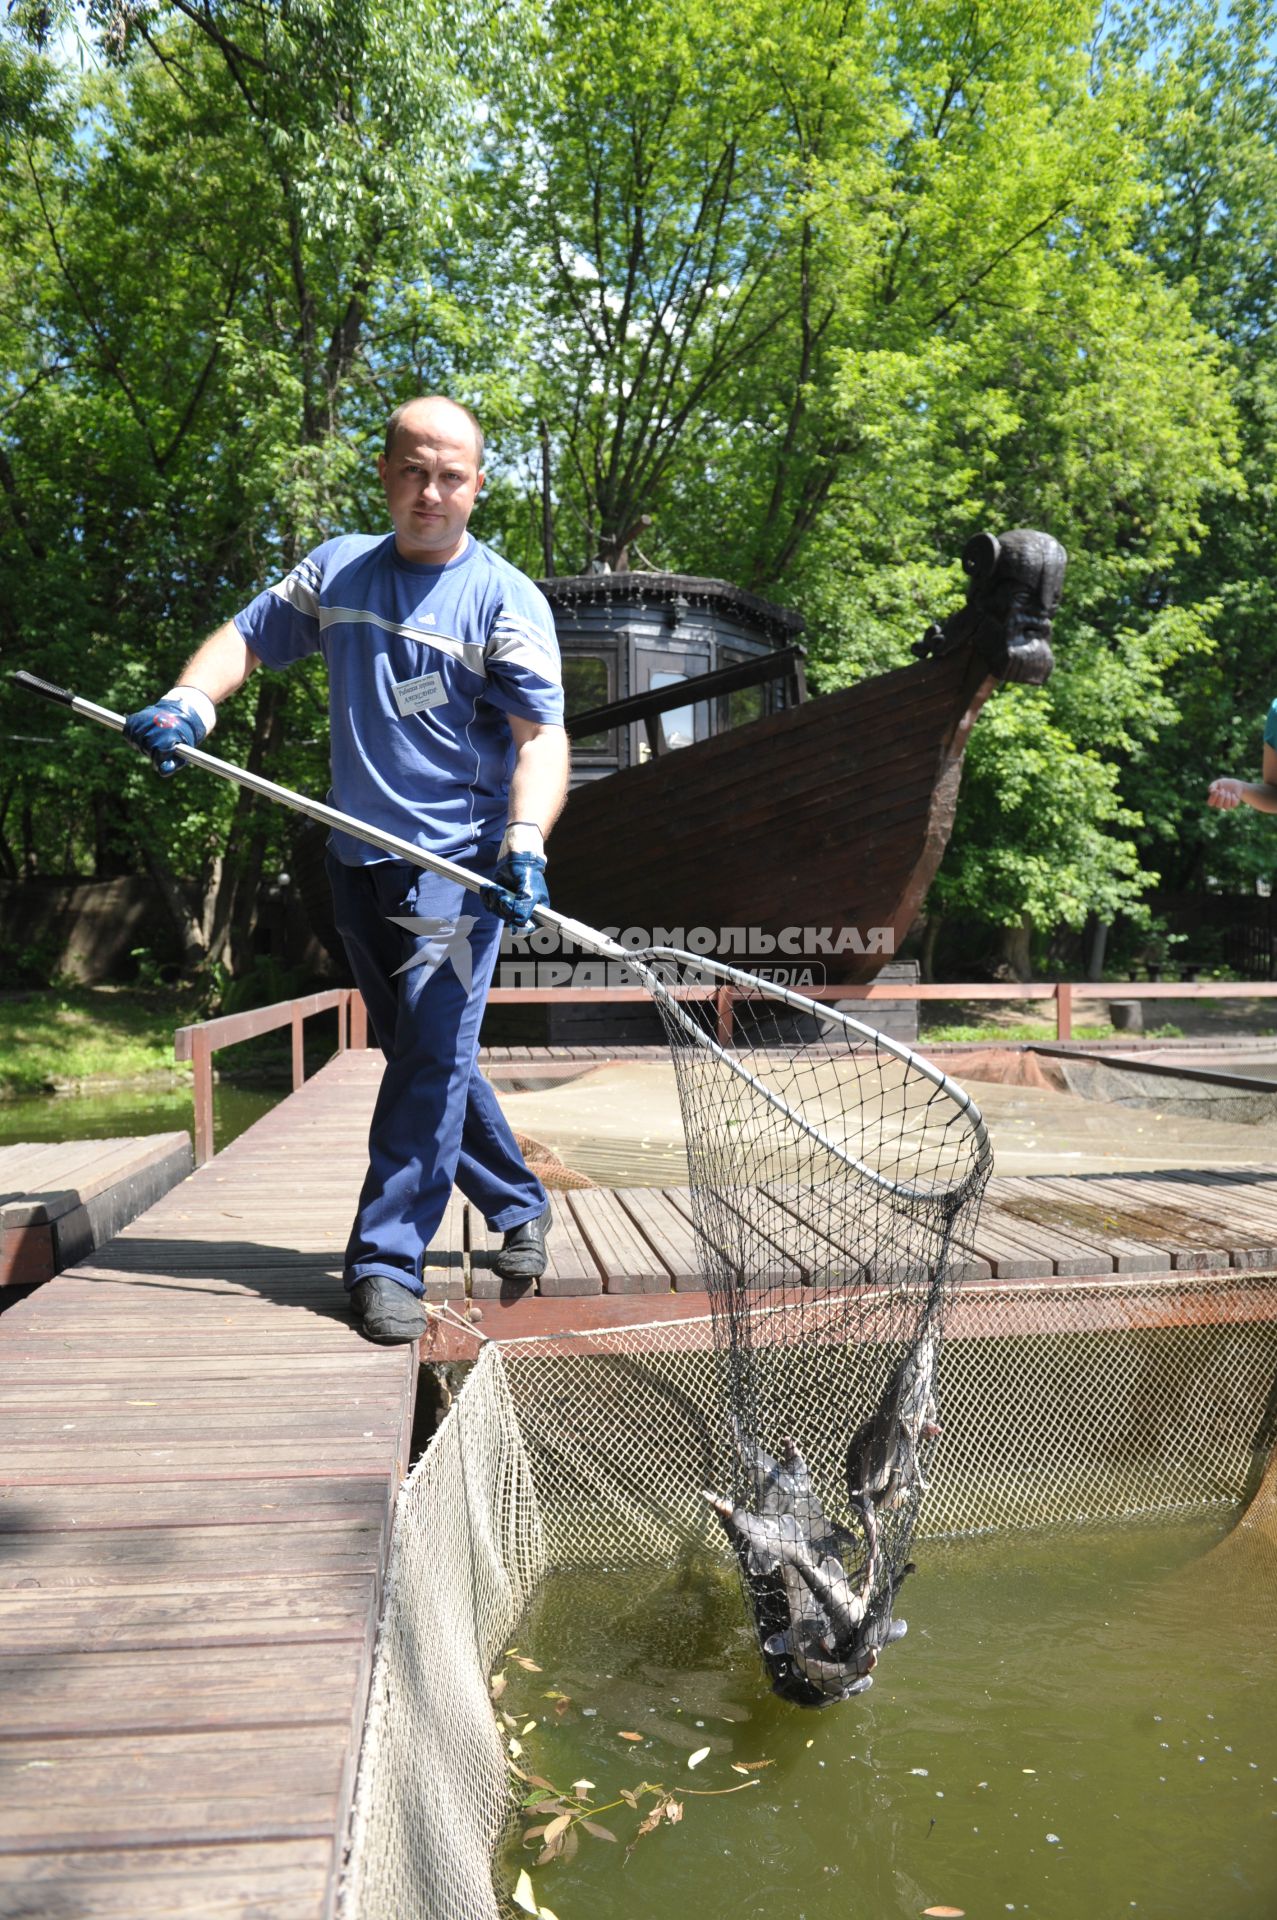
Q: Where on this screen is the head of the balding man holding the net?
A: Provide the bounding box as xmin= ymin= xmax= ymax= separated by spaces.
xmin=376 ymin=399 xmax=484 ymax=566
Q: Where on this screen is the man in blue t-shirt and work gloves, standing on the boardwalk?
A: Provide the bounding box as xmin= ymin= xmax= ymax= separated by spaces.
xmin=125 ymin=396 xmax=568 ymax=1340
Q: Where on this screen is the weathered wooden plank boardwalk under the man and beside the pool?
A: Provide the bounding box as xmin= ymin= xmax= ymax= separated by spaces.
xmin=0 ymin=1052 xmax=1277 ymax=1920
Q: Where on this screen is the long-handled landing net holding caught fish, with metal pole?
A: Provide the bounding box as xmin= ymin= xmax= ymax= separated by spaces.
xmin=13 ymin=674 xmax=991 ymax=1705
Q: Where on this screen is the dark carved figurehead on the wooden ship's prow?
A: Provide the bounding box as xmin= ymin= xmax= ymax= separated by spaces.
xmin=914 ymin=528 xmax=1068 ymax=687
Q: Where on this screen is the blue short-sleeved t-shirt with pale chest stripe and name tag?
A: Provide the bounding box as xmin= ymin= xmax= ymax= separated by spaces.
xmin=234 ymin=534 xmax=563 ymax=866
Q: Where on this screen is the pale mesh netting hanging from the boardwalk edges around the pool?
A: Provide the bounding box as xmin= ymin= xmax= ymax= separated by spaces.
xmin=342 ymin=1275 xmax=1277 ymax=1920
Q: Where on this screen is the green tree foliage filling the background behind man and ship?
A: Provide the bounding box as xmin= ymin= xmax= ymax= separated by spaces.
xmin=0 ymin=0 xmax=1277 ymax=966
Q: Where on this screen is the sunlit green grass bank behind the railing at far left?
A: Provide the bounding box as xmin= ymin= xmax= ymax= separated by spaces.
xmin=0 ymin=987 xmax=198 ymax=1098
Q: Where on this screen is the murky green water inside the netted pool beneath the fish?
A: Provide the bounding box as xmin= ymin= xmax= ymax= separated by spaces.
xmin=501 ymin=1519 xmax=1277 ymax=1920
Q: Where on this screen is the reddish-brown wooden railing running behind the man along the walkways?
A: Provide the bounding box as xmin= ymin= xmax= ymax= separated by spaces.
xmin=173 ymin=979 xmax=1277 ymax=1167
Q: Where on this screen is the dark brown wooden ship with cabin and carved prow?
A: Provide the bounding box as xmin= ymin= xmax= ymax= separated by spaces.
xmin=540 ymin=530 xmax=1064 ymax=985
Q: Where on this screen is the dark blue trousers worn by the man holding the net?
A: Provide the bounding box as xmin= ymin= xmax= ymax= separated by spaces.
xmin=328 ymin=849 xmax=547 ymax=1294
